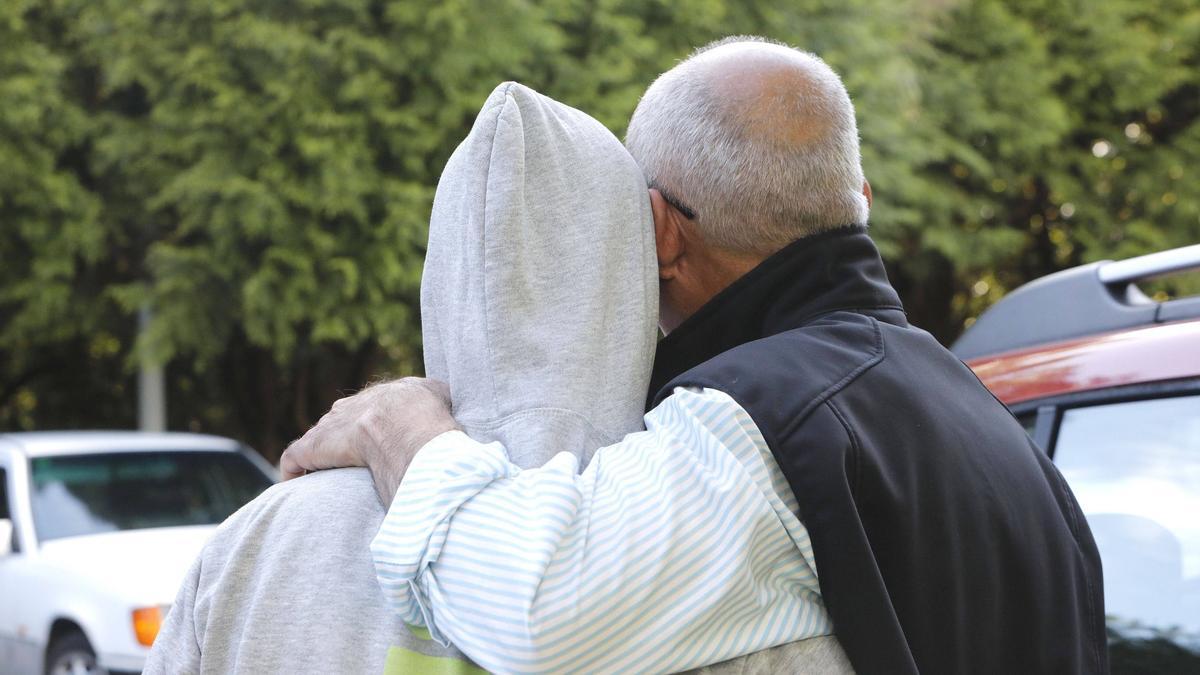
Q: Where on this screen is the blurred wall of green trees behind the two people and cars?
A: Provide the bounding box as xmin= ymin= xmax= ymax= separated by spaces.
xmin=0 ymin=0 xmax=1200 ymax=461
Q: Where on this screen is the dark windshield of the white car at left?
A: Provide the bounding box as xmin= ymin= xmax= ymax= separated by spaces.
xmin=31 ymin=452 xmax=271 ymax=540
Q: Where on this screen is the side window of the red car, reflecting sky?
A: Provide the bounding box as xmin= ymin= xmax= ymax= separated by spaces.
xmin=1055 ymin=395 xmax=1200 ymax=651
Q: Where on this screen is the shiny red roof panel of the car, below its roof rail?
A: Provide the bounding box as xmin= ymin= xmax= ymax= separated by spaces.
xmin=967 ymin=321 xmax=1200 ymax=405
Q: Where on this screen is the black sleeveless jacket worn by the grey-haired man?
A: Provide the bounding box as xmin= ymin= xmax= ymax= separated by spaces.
xmin=649 ymin=228 xmax=1108 ymax=674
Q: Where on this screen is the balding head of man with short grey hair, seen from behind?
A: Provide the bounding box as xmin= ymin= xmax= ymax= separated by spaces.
xmin=625 ymin=37 xmax=870 ymax=330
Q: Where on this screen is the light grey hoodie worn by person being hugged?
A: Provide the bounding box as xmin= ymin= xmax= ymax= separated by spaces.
xmin=146 ymin=83 xmax=845 ymax=674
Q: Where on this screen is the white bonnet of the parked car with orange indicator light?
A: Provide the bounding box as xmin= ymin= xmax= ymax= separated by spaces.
xmin=38 ymin=525 xmax=217 ymax=605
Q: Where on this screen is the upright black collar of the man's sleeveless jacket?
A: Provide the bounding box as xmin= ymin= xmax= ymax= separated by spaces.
xmin=649 ymin=227 xmax=905 ymax=401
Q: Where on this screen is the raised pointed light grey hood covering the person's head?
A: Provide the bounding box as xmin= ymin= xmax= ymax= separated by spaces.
xmin=421 ymin=83 xmax=658 ymax=466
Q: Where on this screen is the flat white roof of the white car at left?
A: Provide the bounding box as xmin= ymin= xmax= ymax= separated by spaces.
xmin=0 ymin=431 xmax=241 ymax=458
